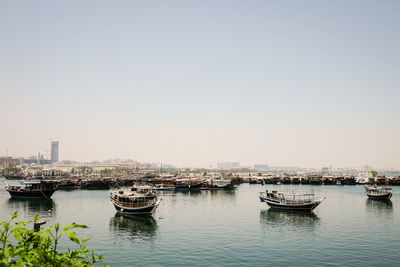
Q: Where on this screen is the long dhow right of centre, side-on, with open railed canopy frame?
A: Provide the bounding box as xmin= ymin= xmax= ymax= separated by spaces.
xmin=259 ymin=190 xmax=325 ymax=211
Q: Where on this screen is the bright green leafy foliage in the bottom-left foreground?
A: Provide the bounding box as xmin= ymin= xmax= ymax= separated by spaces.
xmin=0 ymin=213 xmax=103 ymax=266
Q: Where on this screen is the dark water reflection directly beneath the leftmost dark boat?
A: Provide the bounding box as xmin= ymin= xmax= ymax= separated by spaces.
xmin=8 ymin=198 xmax=56 ymax=214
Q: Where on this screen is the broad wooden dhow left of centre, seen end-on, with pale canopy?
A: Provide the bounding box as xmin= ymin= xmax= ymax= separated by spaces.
xmin=110 ymin=186 xmax=161 ymax=215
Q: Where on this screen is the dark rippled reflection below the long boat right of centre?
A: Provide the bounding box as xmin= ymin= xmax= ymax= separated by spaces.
xmin=260 ymin=209 xmax=319 ymax=229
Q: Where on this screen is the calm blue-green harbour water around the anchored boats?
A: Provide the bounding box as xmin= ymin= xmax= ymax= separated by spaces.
xmin=0 ymin=180 xmax=400 ymax=266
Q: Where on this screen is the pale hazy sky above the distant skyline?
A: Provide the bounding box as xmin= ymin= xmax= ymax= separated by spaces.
xmin=0 ymin=0 xmax=400 ymax=168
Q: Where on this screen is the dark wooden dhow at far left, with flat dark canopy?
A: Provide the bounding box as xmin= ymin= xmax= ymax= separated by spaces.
xmin=6 ymin=180 xmax=57 ymax=199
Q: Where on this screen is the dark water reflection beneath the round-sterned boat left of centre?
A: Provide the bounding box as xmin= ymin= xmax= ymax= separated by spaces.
xmin=110 ymin=213 xmax=158 ymax=243
